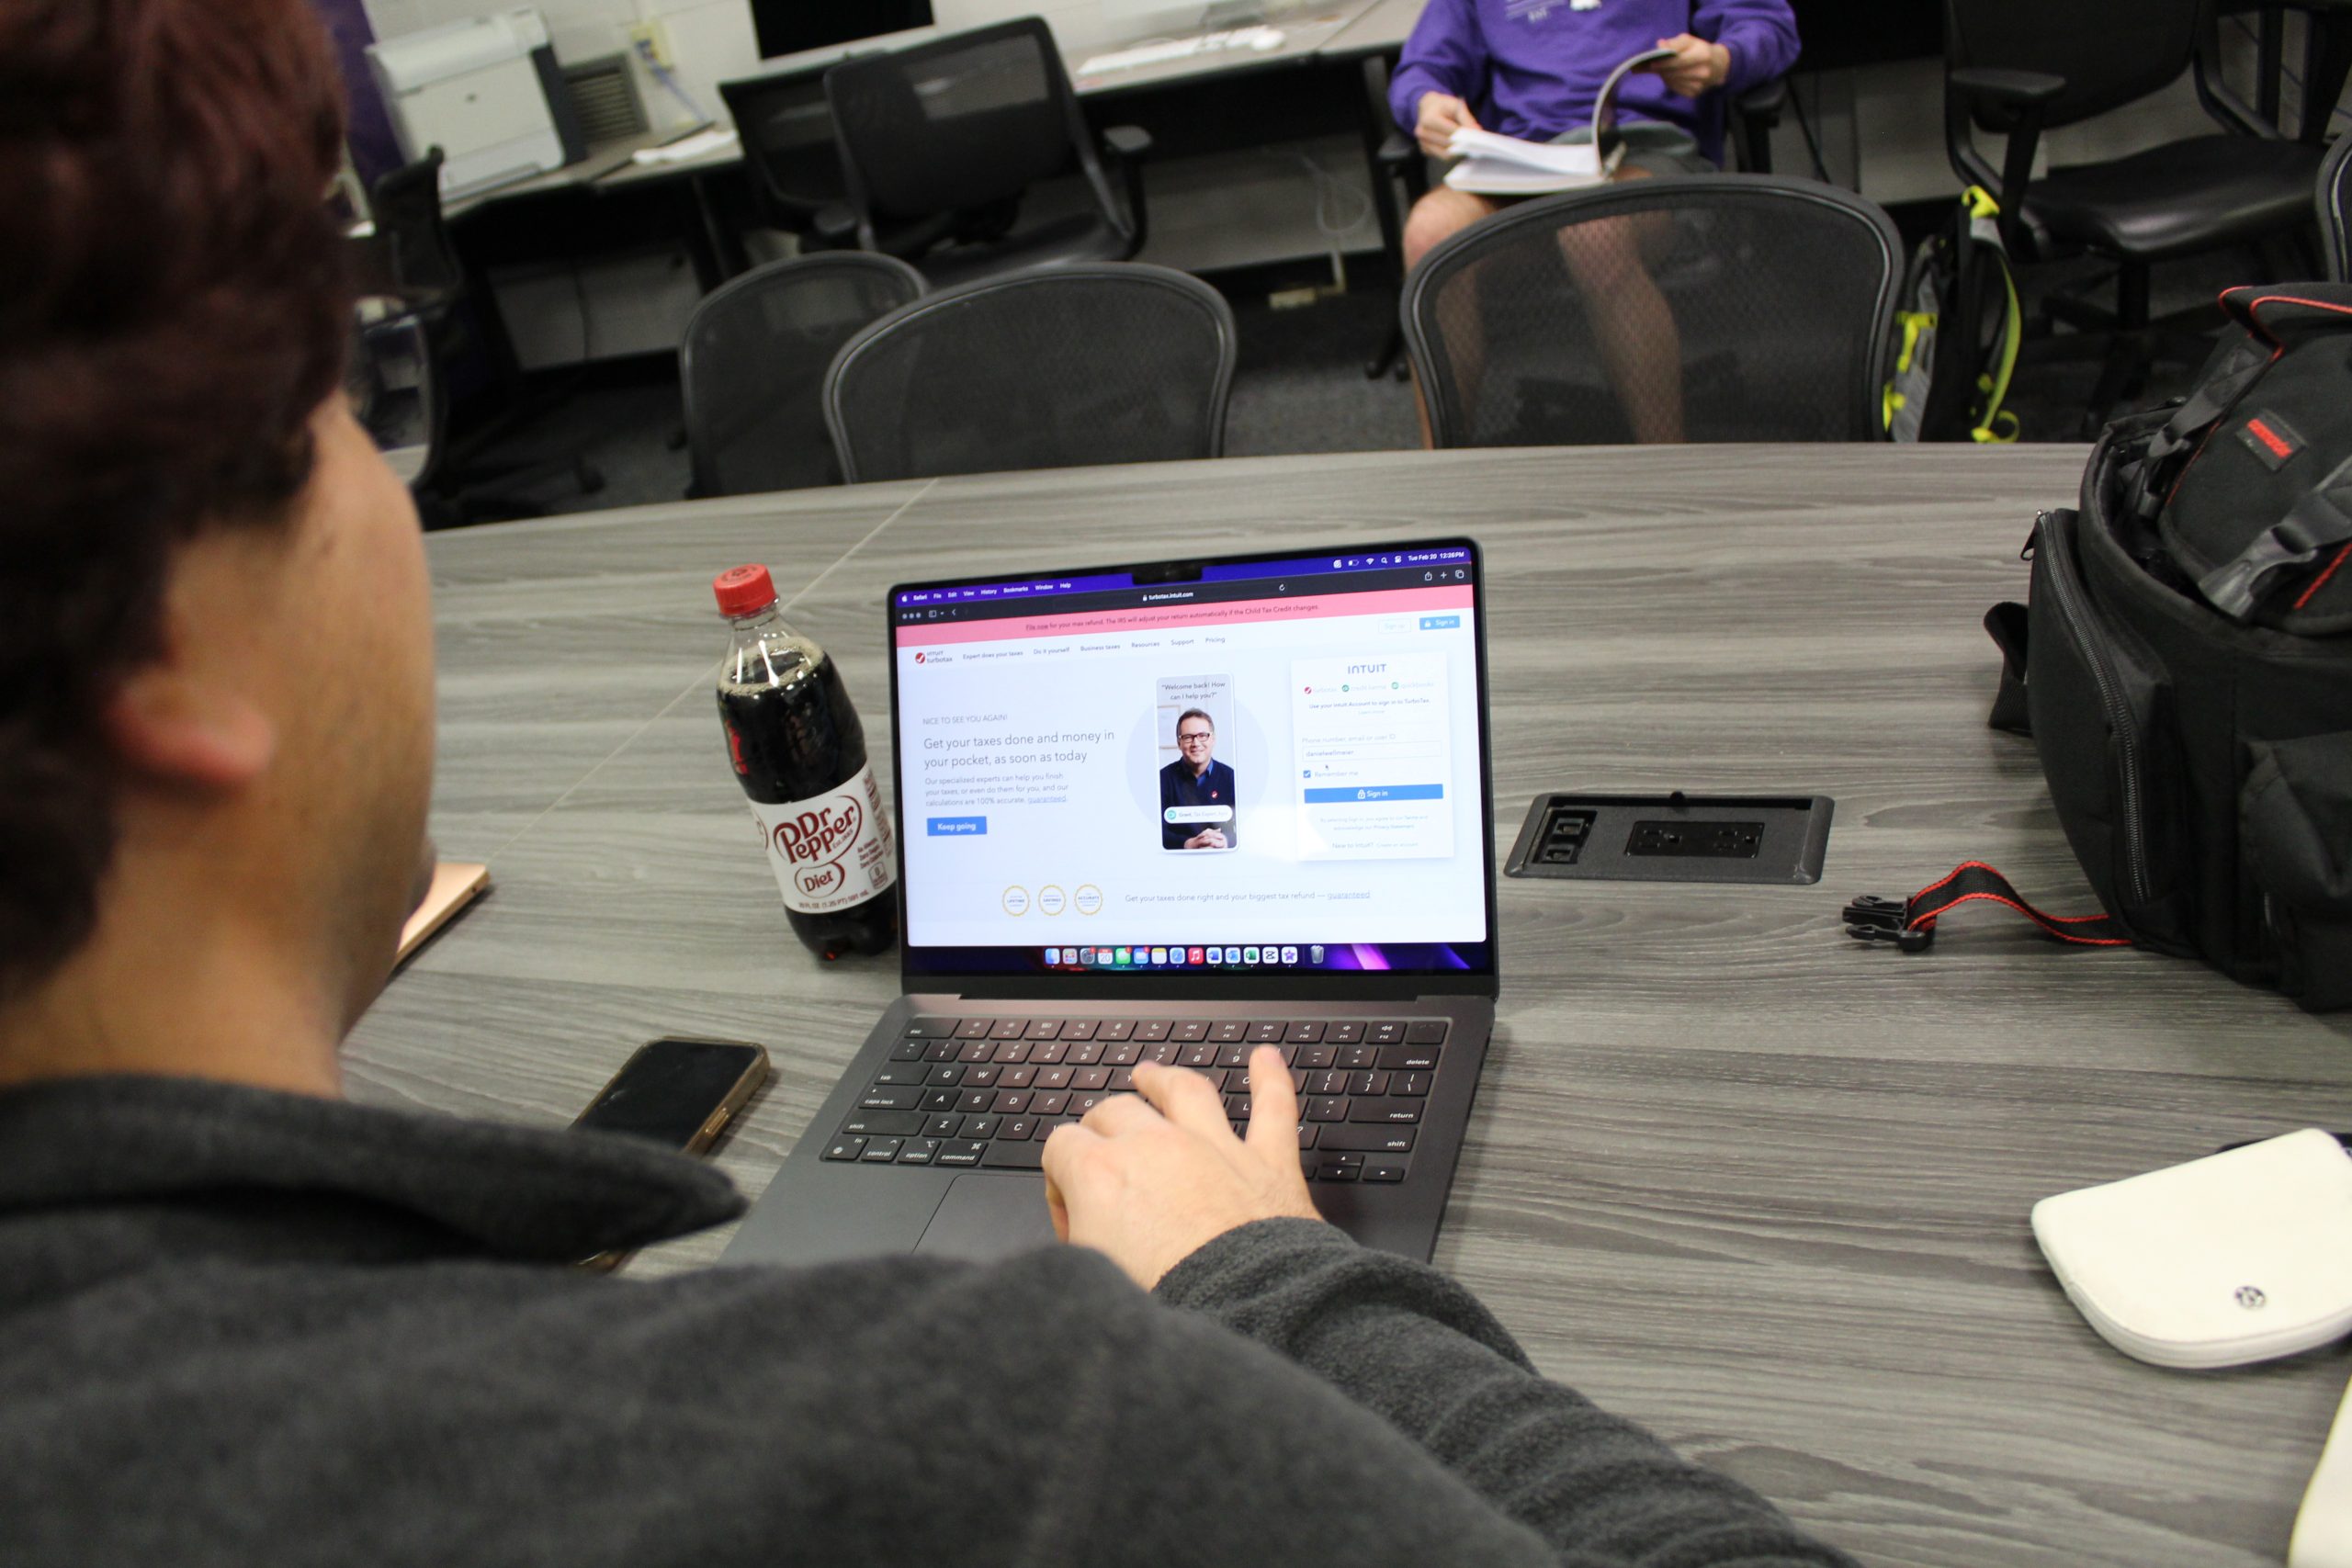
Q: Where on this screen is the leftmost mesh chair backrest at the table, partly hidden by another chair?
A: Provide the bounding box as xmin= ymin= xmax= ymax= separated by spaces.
xmin=677 ymin=252 xmax=924 ymax=496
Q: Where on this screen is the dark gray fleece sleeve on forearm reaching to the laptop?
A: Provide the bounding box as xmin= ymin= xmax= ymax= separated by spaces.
xmin=1155 ymin=1220 xmax=1849 ymax=1568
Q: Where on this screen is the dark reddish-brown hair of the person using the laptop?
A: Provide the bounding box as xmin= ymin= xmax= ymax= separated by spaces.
xmin=0 ymin=0 xmax=348 ymax=997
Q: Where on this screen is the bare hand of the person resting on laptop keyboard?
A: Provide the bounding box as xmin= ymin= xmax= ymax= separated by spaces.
xmin=1045 ymin=1046 xmax=1322 ymax=1291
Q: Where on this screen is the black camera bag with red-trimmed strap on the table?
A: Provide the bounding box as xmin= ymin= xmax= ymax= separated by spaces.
xmin=1847 ymin=285 xmax=2352 ymax=1010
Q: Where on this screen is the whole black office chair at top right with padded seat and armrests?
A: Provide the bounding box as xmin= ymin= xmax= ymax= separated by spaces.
xmin=1945 ymin=0 xmax=2352 ymax=419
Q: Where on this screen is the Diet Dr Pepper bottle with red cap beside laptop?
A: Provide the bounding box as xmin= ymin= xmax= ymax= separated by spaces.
xmin=710 ymin=567 xmax=899 ymax=959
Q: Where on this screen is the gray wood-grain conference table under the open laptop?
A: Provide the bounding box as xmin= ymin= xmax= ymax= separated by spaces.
xmin=345 ymin=446 xmax=2352 ymax=1568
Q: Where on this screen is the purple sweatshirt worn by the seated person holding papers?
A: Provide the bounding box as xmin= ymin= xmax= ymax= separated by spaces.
xmin=1387 ymin=0 xmax=1797 ymax=163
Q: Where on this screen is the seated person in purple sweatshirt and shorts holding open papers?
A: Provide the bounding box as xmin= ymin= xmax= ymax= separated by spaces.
xmin=1387 ymin=0 xmax=1797 ymax=442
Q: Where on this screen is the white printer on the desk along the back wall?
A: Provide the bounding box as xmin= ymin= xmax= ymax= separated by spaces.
xmin=367 ymin=9 xmax=588 ymax=200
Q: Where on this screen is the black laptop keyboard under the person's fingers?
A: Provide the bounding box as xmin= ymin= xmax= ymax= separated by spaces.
xmin=826 ymin=1018 xmax=1446 ymax=1182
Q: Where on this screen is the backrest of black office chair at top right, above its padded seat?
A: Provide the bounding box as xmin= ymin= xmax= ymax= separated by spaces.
xmin=1943 ymin=0 xmax=2211 ymax=130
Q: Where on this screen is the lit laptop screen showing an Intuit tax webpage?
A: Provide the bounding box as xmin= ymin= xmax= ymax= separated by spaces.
xmin=889 ymin=541 xmax=1494 ymax=978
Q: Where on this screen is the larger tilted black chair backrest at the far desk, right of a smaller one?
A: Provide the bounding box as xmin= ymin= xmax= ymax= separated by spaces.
xmin=826 ymin=17 xmax=1117 ymax=236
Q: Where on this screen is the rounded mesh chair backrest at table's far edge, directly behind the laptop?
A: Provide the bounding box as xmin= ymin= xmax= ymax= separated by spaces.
xmin=826 ymin=264 xmax=1235 ymax=482
